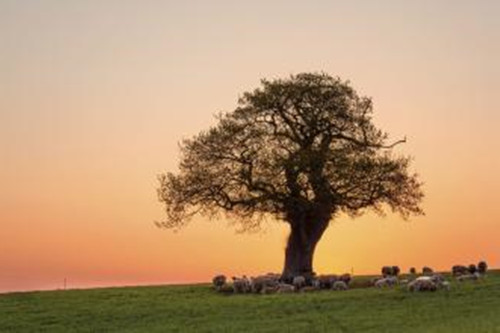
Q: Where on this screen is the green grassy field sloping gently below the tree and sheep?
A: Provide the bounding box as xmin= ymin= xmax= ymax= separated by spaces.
xmin=0 ymin=271 xmax=500 ymax=333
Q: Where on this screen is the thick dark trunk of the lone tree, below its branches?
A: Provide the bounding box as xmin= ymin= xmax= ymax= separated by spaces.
xmin=282 ymin=217 xmax=328 ymax=282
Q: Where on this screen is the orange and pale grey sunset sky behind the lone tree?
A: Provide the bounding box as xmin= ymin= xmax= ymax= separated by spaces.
xmin=0 ymin=0 xmax=500 ymax=292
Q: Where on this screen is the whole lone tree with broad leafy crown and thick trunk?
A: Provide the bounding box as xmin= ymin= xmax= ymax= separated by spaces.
xmin=158 ymin=73 xmax=423 ymax=279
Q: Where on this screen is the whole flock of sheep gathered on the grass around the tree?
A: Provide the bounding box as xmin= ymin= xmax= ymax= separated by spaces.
xmin=212 ymin=261 xmax=488 ymax=294
